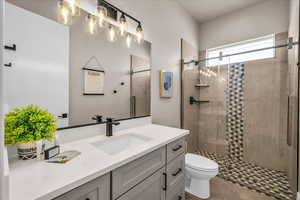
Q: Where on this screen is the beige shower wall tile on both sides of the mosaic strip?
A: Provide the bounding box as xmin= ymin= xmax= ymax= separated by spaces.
xmin=199 ymin=33 xmax=288 ymax=171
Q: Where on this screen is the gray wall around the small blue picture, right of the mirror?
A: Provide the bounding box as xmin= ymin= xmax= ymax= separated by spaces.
xmin=104 ymin=0 xmax=199 ymax=127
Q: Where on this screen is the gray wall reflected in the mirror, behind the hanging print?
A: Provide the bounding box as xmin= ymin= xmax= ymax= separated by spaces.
xmin=70 ymin=12 xmax=151 ymax=125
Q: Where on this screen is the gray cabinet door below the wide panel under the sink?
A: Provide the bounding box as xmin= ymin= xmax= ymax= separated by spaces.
xmin=118 ymin=168 xmax=166 ymax=200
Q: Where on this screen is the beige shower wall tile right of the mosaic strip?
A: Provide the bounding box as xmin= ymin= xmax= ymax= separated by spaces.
xmin=244 ymin=34 xmax=288 ymax=171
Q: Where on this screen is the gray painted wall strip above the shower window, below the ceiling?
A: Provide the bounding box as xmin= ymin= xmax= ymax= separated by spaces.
xmin=200 ymin=0 xmax=289 ymax=50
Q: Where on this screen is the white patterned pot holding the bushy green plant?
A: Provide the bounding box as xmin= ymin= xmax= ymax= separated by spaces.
xmin=17 ymin=142 xmax=36 ymax=160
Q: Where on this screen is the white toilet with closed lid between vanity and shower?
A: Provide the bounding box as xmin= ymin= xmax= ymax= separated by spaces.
xmin=185 ymin=153 xmax=219 ymax=199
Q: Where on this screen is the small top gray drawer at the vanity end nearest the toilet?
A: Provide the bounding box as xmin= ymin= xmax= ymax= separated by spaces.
xmin=167 ymin=138 xmax=186 ymax=162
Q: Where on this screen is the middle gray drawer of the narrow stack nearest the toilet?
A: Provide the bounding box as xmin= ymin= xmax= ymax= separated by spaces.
xmin=167 ymin=154 xmax=185 ymax=189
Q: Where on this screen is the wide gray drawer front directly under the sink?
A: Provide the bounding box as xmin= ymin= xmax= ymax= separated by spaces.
xmin=112 ymin=147 xmax=166 ymax=199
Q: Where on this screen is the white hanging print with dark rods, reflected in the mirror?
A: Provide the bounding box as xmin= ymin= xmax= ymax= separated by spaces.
xmin=83 ymin=68 xmax=105 ymax=95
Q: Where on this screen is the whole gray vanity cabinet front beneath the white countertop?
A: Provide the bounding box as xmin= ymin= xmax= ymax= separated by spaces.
xmin=53 ymin=139 xmax=186 ymax=200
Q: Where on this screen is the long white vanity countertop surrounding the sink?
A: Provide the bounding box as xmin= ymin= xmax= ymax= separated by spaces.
xmin=10 ymin=124 xmax=189 ymax=200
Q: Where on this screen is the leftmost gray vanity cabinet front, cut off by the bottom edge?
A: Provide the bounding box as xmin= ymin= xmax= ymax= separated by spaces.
xmin=54 ymin=174 xmax=110 ymax=200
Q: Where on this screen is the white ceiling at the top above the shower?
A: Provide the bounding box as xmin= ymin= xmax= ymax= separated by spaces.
xmin=175 ymin=0 xmax=267 ymax=23
